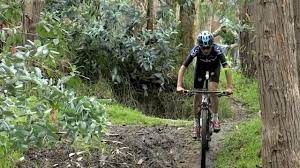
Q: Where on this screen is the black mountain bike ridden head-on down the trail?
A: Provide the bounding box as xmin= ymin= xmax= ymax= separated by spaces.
xmin=184 ymin=72 xmax=228 ymax=168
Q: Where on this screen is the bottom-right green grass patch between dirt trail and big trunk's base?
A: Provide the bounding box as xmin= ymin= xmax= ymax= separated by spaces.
xmin=216 ymin=117 xmax=261 ymax=168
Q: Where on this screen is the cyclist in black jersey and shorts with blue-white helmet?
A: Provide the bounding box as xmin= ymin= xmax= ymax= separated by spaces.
xmin=177 ymin=31 xmax=233 ymax=138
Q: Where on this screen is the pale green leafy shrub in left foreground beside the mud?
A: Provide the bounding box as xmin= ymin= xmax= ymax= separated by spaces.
xmin=0 ymin=38 xmax=106 ymax=156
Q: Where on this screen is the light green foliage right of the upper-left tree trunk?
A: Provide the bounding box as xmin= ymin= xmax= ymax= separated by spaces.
xmin=35 ymin=13 xmax=73 ymax=79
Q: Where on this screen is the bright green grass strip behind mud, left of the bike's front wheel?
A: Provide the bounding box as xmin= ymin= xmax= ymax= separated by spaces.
xmin=107 ymin=104 xmax=192 ymax=125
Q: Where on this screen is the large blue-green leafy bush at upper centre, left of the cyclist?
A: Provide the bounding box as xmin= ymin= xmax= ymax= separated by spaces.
xmin=45 ymin=0 xmax=177 ymax=92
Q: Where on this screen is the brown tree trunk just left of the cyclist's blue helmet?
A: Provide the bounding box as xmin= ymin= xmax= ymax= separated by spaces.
xmin=179 ymin=1 xmax=195 ymax=59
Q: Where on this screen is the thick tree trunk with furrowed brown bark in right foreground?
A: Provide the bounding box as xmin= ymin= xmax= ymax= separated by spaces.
xmin=256 ymin=0 xmax=300 ymax=168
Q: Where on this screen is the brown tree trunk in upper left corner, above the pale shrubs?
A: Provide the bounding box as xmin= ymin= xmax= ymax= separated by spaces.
xmin=23 ymin=0 xmax=44 ymax=41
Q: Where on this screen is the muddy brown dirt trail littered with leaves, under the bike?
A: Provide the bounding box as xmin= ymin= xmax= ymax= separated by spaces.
xmin=17 ymin=99 xmax=255 ymax=168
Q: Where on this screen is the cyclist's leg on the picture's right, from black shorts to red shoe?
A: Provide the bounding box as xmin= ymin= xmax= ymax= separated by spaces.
xmin=209 ymin=65 xmax=221 ymax=132
